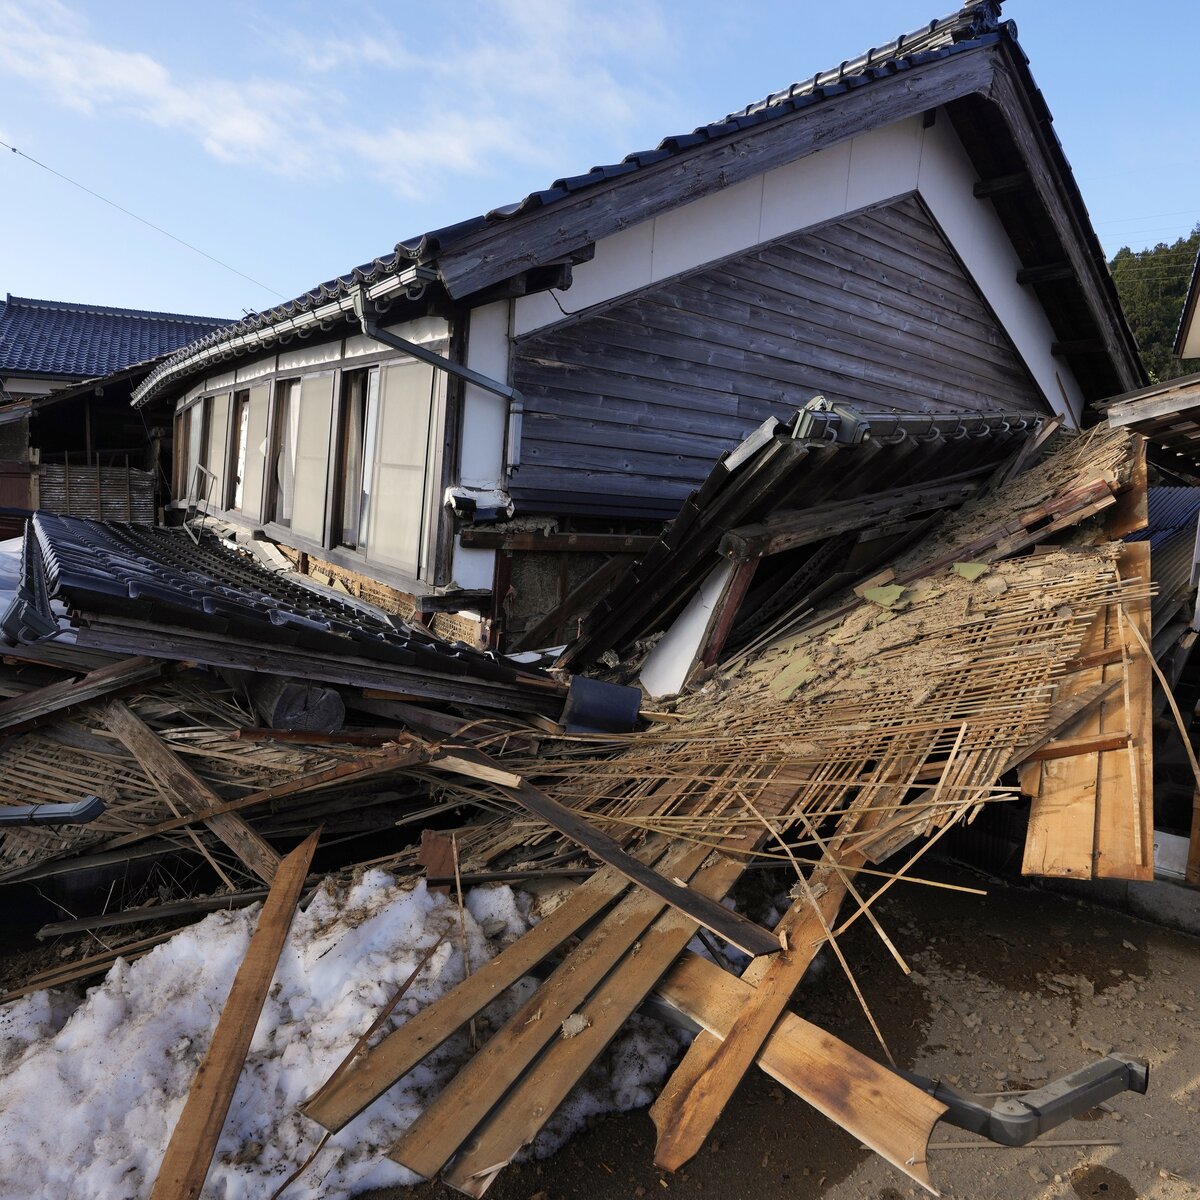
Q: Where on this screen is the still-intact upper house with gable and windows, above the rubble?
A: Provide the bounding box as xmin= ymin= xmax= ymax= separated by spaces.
xmin=124 ymin=0 xmax=1146 ymax=648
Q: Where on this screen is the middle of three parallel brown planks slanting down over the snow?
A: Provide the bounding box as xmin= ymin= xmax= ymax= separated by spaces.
xmin=388 ymin=844 xmax=710 ymax=1178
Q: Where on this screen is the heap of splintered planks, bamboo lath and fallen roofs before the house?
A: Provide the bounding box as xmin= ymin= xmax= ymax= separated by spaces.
xmin=0 ymin=406 xmax=1180 ymax=1196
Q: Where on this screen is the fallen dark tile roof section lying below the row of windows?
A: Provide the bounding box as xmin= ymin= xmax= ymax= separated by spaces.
xmin=0 ymin=512 xmax=564 ymax=713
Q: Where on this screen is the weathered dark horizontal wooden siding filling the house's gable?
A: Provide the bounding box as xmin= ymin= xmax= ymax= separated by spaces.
xmin=511 ymin=196 xmax=1045 ymax=516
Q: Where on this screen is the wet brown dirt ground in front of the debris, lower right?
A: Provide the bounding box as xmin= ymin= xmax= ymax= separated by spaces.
xmin=373 ymin=866 xmax=1200 ymax=1200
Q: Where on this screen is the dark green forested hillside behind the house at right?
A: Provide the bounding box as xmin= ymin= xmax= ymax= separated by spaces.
xmin=1109 ymin=224 xmax=1200 ymax=383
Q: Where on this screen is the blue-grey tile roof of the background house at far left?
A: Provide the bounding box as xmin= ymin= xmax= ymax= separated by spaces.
xmin=0 ymin=295 xmax=229 ymax=379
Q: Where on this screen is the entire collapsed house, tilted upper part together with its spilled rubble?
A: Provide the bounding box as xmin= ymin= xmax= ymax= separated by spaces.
xmin=0 ymin=2 xmax=1200 ymax=1196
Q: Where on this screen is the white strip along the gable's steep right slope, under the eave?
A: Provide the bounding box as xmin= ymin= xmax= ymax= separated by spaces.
xmin=919 ymin=113 xmax=1084 ymax=426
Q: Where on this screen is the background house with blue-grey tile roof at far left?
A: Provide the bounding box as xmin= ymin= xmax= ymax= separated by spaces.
xmin=0 ymin=295 xmax=224 ymax=534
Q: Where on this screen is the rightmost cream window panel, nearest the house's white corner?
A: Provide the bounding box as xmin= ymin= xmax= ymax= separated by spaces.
xmin=367 ymin=362 xmax=433 ymax=577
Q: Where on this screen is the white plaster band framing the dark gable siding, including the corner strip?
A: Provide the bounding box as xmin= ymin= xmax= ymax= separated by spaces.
xmin=454 ymin=113 xmax=1082 ymax=587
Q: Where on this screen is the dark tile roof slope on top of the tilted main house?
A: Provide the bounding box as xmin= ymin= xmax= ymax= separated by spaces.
xmin=131 ymin=0 xmax=1015 ymax=402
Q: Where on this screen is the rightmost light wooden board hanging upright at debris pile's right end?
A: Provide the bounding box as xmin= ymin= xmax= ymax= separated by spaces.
xmin=1096 ymin=547 xmax=1154 ymax=880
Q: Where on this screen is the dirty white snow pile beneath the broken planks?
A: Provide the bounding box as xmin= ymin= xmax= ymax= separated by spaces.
xmin=0 ymin=871 xmax=677 ymax=1200
